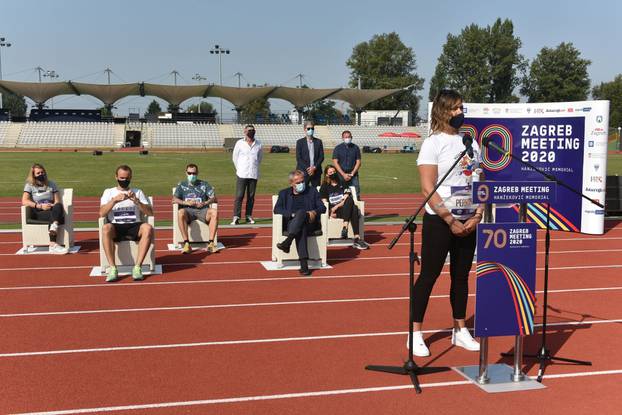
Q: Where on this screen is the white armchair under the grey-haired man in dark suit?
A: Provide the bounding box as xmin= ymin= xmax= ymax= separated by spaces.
xmin=272 ymin=195 xmax=328 ymax=267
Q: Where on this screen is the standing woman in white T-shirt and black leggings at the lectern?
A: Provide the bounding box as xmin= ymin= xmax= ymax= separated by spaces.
xmin=413 ymin=90 xmax=483 ymax=356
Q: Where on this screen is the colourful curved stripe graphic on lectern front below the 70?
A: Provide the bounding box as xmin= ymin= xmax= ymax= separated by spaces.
xmin=476 ymin=261 xmax=536 ymax=336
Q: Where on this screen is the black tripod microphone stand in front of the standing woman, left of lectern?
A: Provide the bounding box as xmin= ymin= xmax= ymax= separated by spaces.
xmin=365 ymin=144 xmax=471 ymax=394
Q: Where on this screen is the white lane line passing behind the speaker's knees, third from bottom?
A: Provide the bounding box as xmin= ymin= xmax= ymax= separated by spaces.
xmin=0 ymin=287 xmax=622 ymax=318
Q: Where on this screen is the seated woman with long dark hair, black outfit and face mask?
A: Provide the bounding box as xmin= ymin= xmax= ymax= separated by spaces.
xmin=320 ymin=164 xmax=369 ymax=249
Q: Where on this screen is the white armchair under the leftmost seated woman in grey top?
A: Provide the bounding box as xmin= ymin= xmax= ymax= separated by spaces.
xmin=21 ymin=189 xmax=73 ymax=249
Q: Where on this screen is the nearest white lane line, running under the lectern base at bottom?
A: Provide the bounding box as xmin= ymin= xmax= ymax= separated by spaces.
xmin=14 ymin=369 xmax=622 ymax=415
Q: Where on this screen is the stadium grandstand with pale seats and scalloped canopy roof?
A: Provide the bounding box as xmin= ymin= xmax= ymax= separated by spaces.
xmin=0 ymin=80 xmax=427 ymax=150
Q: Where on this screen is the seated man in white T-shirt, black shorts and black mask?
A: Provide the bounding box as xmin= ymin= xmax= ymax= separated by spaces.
xmin=99 ymin=165 xmax=153 ymax=282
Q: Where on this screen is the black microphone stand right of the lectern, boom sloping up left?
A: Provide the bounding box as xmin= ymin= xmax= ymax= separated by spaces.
xmin=483 ymin=139 xmax=604 ymax=383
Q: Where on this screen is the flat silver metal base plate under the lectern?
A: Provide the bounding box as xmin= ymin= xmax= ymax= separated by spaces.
xmin=454 ymin=364 xmax=546 ymax=393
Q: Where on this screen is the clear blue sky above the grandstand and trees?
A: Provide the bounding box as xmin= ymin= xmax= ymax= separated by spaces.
xmin=0 ymin=0 xmax=622 ymax=114
